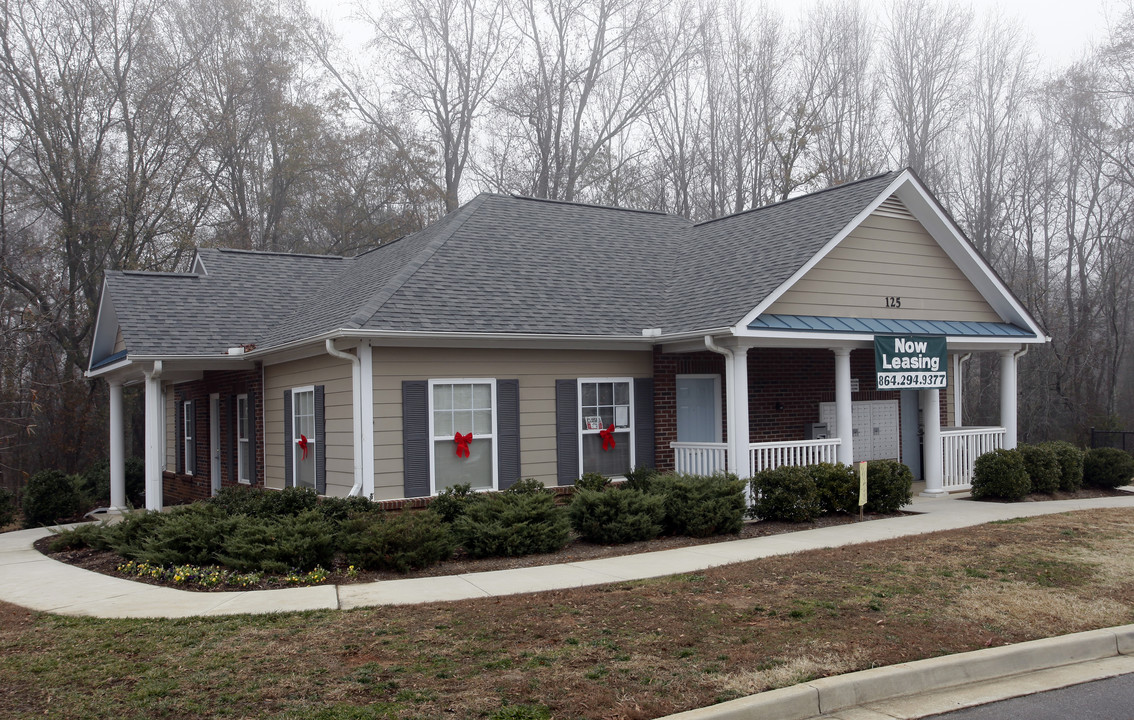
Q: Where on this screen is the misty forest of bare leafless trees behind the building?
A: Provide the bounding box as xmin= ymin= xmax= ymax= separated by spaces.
xmin=0 ymin=0 xmax=1134 ymax=485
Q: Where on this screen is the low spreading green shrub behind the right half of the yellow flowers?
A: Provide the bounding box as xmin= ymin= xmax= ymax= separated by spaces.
xmin=214 ymin=509 xmax=336 ymax=574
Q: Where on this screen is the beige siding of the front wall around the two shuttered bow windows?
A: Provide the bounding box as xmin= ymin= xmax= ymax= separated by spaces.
xmin=374 ymin=347 xmax=653 ymax=500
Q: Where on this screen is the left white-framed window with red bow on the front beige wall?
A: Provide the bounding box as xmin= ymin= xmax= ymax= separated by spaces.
xmin=429 ymin=380 xmax=497 ymax=494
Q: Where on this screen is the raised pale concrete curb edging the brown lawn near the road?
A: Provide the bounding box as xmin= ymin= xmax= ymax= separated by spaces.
xmin=661 ymin=625 xmax=1134 ymax=720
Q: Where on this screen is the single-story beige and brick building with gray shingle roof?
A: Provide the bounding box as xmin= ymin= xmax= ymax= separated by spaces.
xmin=88 ymin=170 xmax=1048 ymax=508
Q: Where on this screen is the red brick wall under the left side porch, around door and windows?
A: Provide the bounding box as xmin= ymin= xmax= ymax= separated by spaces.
xmin=162 ymin=369 xmax=264 ymax=505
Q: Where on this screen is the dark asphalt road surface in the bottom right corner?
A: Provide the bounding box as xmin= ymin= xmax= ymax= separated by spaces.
xmin=924 ymin=675 xmax=1134 ymax=720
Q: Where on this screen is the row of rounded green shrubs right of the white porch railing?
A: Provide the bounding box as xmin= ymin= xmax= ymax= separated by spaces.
xmin=973 ymin=441 xmax=1134 ymax=500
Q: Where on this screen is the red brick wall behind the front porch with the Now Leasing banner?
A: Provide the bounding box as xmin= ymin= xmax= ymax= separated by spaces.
xmin=653 ymin=348 xmax=947 ymax=469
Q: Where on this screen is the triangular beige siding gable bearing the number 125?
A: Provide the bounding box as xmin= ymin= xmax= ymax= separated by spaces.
xmin=767 ymin=198 xmax=1000 ymax=322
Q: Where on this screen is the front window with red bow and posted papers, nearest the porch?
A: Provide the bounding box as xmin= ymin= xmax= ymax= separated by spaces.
xmin=578 ymin=378 xmax=634 ymax=476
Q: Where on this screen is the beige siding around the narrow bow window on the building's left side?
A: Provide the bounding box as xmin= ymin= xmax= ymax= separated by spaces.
xmin=264 ymin=355 xmax=354 ymax=497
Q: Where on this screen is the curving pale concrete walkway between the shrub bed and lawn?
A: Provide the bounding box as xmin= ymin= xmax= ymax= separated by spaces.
xmin=0 ymin=496 xmax=1134 ymax=618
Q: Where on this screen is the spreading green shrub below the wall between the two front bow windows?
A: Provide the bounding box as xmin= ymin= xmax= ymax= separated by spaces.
xmin=452 ymin=492 xmax=568 ymax=558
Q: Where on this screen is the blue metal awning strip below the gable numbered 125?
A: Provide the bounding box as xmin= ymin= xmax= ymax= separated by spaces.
xmin=748 ymin=315 xmax=1035 ymax=338
